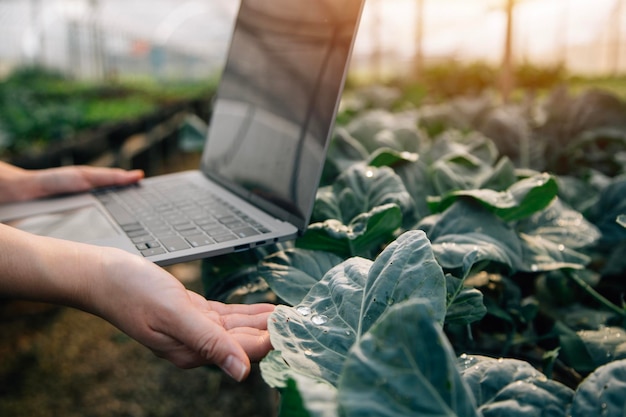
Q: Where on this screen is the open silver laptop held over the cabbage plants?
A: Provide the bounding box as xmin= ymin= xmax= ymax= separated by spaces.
xmin=0 ymin=0 xmax=364 ymax=265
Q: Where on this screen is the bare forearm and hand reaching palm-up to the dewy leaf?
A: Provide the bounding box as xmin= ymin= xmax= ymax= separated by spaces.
xmin=0 ymin=225 xmax=274 ymax=381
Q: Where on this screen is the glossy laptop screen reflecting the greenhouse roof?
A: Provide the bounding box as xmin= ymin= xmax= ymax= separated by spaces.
xmin=202 ymin=0 xmax=363 ymax=230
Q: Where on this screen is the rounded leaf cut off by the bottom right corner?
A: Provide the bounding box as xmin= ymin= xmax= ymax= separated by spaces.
xmin=571 ymin=360 xmax=626 ymax=417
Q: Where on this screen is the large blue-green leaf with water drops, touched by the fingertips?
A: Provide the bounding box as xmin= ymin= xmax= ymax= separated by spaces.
xmin=268 ymin=231 xmax=446 ymax=384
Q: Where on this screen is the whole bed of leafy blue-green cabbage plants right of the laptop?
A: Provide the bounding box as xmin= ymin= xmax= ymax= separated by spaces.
xmin=208 ymin=86 xmax=626 ymax=417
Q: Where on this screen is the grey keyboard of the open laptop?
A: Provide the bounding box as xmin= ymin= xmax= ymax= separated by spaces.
xmin=94 ymin=182 xmax=269 ymax=256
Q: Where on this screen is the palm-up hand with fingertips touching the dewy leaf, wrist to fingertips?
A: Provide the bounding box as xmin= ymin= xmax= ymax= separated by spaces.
xmin=92 ymin=251 xmax=274 ymax=381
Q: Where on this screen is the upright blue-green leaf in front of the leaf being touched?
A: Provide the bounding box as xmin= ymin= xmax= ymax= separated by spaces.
xmin=338 ymin=299 xmax=478 ymax=417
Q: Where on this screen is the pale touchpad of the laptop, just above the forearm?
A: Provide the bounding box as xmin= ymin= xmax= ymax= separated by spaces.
xmin=6 ymin=205 xmax=118 ymax=243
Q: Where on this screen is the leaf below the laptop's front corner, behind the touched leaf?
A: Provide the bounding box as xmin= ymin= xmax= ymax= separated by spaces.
xmin=258 ymin=248 xmax=343 ymax=305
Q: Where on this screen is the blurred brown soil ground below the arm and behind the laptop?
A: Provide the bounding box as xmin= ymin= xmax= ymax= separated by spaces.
xmin=0 ymin=149 xmax=277 ymax=417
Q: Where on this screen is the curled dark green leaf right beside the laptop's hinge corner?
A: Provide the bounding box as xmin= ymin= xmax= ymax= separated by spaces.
xmin=296 ymin=204 xmax=402 ymax=258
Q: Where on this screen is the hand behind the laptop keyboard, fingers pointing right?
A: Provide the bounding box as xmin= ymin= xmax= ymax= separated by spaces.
xmin=0 ymin=162 xmax=144 ymax=203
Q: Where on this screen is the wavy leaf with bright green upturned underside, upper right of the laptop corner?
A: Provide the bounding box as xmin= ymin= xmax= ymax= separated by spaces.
xmin=429 ymin=174 xmax=558 ymax=221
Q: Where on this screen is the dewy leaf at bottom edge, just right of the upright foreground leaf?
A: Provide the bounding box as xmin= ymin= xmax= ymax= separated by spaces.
xmin=459 ymin=355 xmax=572 ymax=417
